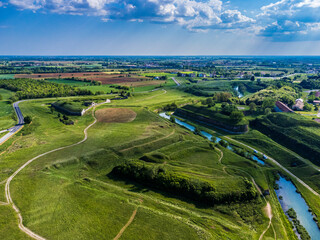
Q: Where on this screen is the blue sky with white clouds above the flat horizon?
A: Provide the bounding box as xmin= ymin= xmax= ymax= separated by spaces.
xmin=0 ymin=0 xmax=320 ymax=55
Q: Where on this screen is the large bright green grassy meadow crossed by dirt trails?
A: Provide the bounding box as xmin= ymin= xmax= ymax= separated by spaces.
xmin=0 ymin=90 xmax=298 ymax=239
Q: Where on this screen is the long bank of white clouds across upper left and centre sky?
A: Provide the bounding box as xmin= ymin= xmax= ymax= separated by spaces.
xmin=9 ymin=0 xmax=254 ymax=31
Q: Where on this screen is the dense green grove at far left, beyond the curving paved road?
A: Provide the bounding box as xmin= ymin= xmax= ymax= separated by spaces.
xmin=0 ymin=79 xmax=94 ymax=101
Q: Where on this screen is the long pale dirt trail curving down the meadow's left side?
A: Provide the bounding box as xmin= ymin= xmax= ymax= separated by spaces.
xmin=5 ymin=108 xmax=97 ymax=240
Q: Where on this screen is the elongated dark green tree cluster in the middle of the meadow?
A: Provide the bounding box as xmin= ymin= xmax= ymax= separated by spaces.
xmin=112 ymin=161 xmax=258 ymax=205
